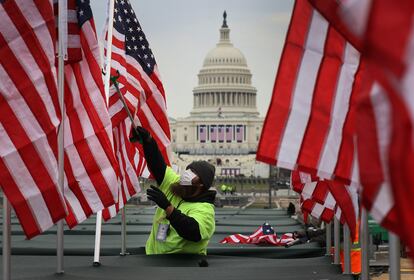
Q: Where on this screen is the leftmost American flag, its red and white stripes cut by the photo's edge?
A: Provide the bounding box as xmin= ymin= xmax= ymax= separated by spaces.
xmin=0 ymin=0 xmax=66 ymax=238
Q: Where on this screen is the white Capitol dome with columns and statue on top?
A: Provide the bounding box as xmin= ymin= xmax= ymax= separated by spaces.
xmin=191 ymin=12 xmax=259 ymax=117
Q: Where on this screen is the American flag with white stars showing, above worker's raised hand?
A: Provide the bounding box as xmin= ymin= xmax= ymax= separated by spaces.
xmin=109 ymin=0 xmax=170 ymax=153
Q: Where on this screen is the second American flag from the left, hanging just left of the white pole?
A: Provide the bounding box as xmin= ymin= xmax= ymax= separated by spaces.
xmin=60 ymin=0 xmax=119 ymax=227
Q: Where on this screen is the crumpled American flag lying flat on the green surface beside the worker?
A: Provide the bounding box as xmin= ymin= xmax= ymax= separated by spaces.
xmin=220 ymin=223 xmax=294 ymax=246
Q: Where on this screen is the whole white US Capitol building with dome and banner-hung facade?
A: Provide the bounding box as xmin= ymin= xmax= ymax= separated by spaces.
xmin=170 ymin=12 xmax=269 ymax=177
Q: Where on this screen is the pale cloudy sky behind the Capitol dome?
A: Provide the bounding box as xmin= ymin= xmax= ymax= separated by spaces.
xmin=91 ymin=0 xmax=293 ymax=118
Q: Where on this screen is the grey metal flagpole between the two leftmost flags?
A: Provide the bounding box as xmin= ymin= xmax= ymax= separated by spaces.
xmin=56 ymin=0 xmax=68 ymax=274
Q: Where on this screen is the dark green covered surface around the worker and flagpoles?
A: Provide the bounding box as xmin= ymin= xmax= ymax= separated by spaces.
xmin=0 ymin=208 xmax=351 ymax=280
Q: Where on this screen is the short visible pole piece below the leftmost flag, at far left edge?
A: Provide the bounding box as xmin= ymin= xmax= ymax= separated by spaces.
xmin=2 ymin=193 xmax=11 ymax=280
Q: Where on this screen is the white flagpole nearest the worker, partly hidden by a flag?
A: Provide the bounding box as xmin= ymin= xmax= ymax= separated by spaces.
xmin=93 ymin=0 xmax=115 ymax=266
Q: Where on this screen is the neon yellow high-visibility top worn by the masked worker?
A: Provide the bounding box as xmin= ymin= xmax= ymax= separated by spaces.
xmin=145 ymin=166 xmax=216 ymax=255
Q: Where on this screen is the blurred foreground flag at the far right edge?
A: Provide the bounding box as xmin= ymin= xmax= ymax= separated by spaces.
xmin=311 ymin=0 xmax=414 ymax=256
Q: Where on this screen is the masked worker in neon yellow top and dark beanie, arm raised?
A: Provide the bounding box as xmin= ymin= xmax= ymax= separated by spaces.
xmin=131 ymin=127 xmax=216 ymax=255
